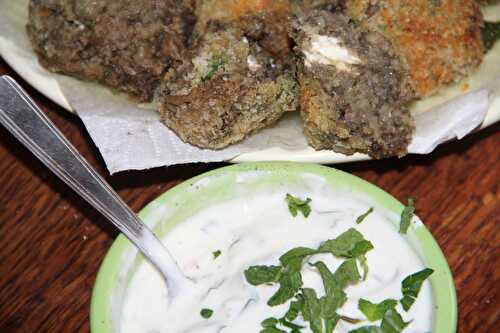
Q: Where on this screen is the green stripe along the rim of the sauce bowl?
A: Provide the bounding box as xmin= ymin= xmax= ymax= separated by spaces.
xmin=90 ymin=162 xmax=457 ymax=333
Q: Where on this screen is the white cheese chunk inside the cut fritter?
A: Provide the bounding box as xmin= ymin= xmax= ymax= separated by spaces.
xmin=304 ymin=35 xmax=361 ymax=71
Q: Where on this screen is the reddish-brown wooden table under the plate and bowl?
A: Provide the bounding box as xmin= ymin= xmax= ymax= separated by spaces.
xmin=0 ymin=60 xmax=500 ymax=333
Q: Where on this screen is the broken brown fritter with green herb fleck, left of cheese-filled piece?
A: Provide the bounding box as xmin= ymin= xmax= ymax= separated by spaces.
xmin=158 ymin=23 xmax=298 ymax=149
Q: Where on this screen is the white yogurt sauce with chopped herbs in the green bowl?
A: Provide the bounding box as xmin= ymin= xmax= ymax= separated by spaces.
xmin=119 ymin=186 xmax=433 ymax=333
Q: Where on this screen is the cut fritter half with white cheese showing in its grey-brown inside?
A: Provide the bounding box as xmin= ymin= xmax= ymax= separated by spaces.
xmin=292 ymin=10 xmax=414 ymax=158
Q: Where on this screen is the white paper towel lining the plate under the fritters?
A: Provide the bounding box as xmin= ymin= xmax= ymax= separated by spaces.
xmin=0 ymin=0 xmax=500 ymax=173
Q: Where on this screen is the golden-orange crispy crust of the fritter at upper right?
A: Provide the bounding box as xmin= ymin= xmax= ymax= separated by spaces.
xmin=345 ymin=0 xmax=483 ymax=97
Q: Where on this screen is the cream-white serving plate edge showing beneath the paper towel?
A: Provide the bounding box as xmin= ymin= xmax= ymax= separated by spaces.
xmin=0 ymin=0 xmax=500 ymax=164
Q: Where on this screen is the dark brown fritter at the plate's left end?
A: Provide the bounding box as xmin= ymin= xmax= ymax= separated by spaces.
xmin=27 ymin=0 xmax=195 ymax=101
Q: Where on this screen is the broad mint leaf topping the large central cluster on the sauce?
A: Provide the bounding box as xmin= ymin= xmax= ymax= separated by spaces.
xmin=319 ymin=228 xmax=373 ymax=258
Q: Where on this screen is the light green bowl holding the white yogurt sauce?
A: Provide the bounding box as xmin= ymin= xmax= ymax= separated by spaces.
xmin=90 ymin=162 xmax=457 ymax=333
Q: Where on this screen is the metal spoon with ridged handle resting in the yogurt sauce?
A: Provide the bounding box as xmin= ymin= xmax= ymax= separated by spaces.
xmin=0 ymin=76 xmax=191 ymax=301
